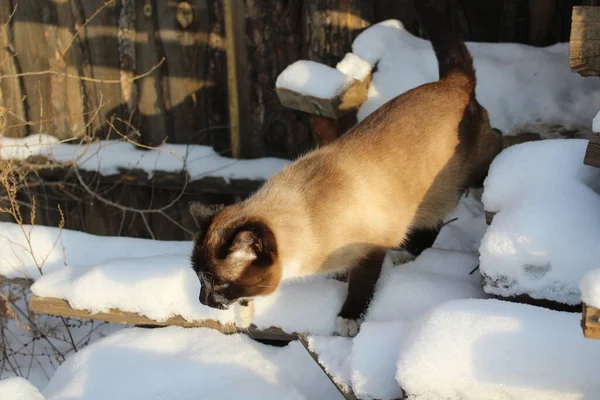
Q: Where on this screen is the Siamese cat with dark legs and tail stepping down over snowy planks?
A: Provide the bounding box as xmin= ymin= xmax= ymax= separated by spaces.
xmin=190 ymin=0 xmax=502 ymax=336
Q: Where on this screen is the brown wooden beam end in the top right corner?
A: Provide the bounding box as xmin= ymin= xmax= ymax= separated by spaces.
xmin=569 ymin=6 xmax=600 ymax=76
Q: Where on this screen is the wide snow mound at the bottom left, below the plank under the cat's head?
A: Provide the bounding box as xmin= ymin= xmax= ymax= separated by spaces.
xmin=42 ymin=327 xmax=341 ymax=400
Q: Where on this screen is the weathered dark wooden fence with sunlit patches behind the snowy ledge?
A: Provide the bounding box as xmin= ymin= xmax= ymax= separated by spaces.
xmin=0 ymin=0 xmax=598 ymax=239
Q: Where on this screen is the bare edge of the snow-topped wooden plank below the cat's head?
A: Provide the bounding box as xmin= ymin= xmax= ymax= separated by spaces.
xmin=29 ymin=295 xmax=297 ymax=341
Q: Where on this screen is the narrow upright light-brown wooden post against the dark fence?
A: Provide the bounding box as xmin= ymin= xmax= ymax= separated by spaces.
xmin=224 ymin=0 xmax=252 ymax=158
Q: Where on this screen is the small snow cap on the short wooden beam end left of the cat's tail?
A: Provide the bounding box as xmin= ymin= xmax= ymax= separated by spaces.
xmin=275 ymin=60 xmax=354 ymax=99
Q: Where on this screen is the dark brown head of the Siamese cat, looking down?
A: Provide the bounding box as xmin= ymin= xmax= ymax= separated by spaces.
xmin=190 ymin=203 xmax=281 ymax=309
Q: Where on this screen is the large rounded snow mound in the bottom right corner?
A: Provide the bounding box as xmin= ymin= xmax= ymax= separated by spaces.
xmin=396 ymin=299 xmax=600 ymax=400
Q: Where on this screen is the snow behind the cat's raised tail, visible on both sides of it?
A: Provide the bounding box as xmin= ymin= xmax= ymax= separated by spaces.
xmin=352 ymin=20 xmax=600 ymax=134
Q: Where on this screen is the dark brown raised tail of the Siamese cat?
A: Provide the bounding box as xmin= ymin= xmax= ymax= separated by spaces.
xmin=414 ymin=0 xmax=476 ymax=90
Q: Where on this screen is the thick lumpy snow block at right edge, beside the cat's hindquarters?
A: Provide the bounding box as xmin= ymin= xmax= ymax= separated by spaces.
xmin=480 ymin=139 xmax=600 ymax=305
